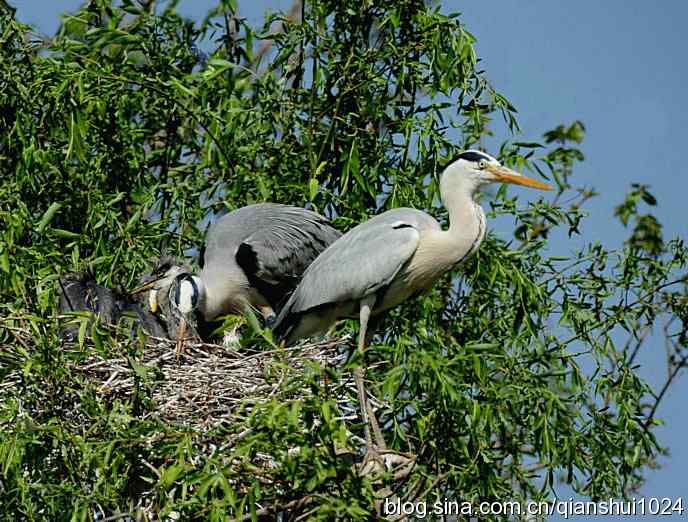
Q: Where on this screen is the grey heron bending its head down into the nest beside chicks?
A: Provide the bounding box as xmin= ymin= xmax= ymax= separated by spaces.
xmin=133 ymin=203 xmax=341 ymax=340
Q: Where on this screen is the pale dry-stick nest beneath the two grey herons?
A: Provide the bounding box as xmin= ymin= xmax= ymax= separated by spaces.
xmin=73 ymin=338 xmax=355 ymax=430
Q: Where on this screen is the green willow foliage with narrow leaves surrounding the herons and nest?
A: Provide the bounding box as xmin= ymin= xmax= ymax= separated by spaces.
xmin=0 ymin=0 xmax=688 ymax=520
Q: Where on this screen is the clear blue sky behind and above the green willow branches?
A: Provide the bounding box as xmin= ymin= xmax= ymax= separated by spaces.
xmin=10 ymin=0 xmax=688 ymax=520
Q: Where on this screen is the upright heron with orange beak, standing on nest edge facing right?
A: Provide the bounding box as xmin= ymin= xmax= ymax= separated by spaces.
xmin=274 ymin=150 xmax=552 ymax=454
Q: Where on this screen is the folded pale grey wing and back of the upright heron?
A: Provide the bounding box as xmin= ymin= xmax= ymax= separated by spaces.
xmin=274 ymin=208 xmax=440 ymax=338
